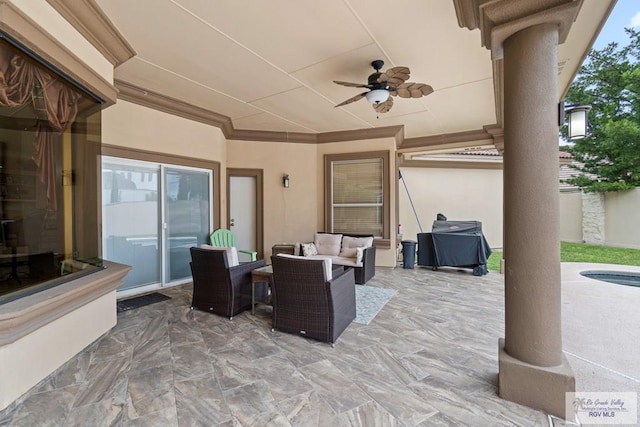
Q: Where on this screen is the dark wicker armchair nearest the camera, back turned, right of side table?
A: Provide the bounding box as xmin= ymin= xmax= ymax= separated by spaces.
xmin=271 ymin=256 xmax=356 ymax=344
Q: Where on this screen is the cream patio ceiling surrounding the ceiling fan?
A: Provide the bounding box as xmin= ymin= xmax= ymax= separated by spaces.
xmin=97 ymin=0 xmax=612 ymax=138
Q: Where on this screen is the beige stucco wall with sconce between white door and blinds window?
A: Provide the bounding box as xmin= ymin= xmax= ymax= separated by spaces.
xmin=225 ymin=141 xmax=319 ymax=259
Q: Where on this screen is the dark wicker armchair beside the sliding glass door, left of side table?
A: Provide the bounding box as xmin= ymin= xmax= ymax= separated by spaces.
xmin=190 ymin=247 xmax=268 ymax=320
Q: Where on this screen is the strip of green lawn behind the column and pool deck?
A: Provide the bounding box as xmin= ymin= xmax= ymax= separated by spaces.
xmin=487 ymin=242 xmax=640 ymax=271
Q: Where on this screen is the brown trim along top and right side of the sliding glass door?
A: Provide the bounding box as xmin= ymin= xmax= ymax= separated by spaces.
xmin=102 ymin=144 xmax=222 ymax=234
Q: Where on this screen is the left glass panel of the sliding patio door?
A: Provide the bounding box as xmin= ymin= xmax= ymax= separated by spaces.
xmin=102 ymin=157 xmax=161 ymax=290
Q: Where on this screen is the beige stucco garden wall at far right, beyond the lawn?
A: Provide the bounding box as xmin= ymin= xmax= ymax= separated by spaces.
xmin=605 ymin=188 xmax=640 ymax=249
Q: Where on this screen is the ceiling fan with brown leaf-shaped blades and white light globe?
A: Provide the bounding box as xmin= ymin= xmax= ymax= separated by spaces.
xmin=333 ymin=59 xmax=433 ymax=113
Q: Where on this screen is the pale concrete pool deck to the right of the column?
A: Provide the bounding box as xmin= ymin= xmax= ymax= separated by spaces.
xmin=562 ymin=263 xmax=640 ymax=396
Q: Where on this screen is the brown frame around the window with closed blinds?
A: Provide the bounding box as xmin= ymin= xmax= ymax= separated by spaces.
xmin=324 ymin=151 xmax=391 ymax=242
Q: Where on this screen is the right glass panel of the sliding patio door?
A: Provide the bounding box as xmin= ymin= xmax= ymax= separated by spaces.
xmin=163 ymin=167 xmax=211 ymax=282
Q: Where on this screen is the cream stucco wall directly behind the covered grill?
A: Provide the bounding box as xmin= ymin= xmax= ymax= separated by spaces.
xmin=398 ymin=167 xmax=502 ymax=248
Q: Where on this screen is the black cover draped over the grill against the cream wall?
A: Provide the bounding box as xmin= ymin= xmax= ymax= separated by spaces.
xmin=418 ymin=221 xmax=491 ymax=276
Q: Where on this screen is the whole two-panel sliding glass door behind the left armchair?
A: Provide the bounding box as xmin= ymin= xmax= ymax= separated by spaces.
xmin=102 ymin=157 xmax=212 ymax=291
